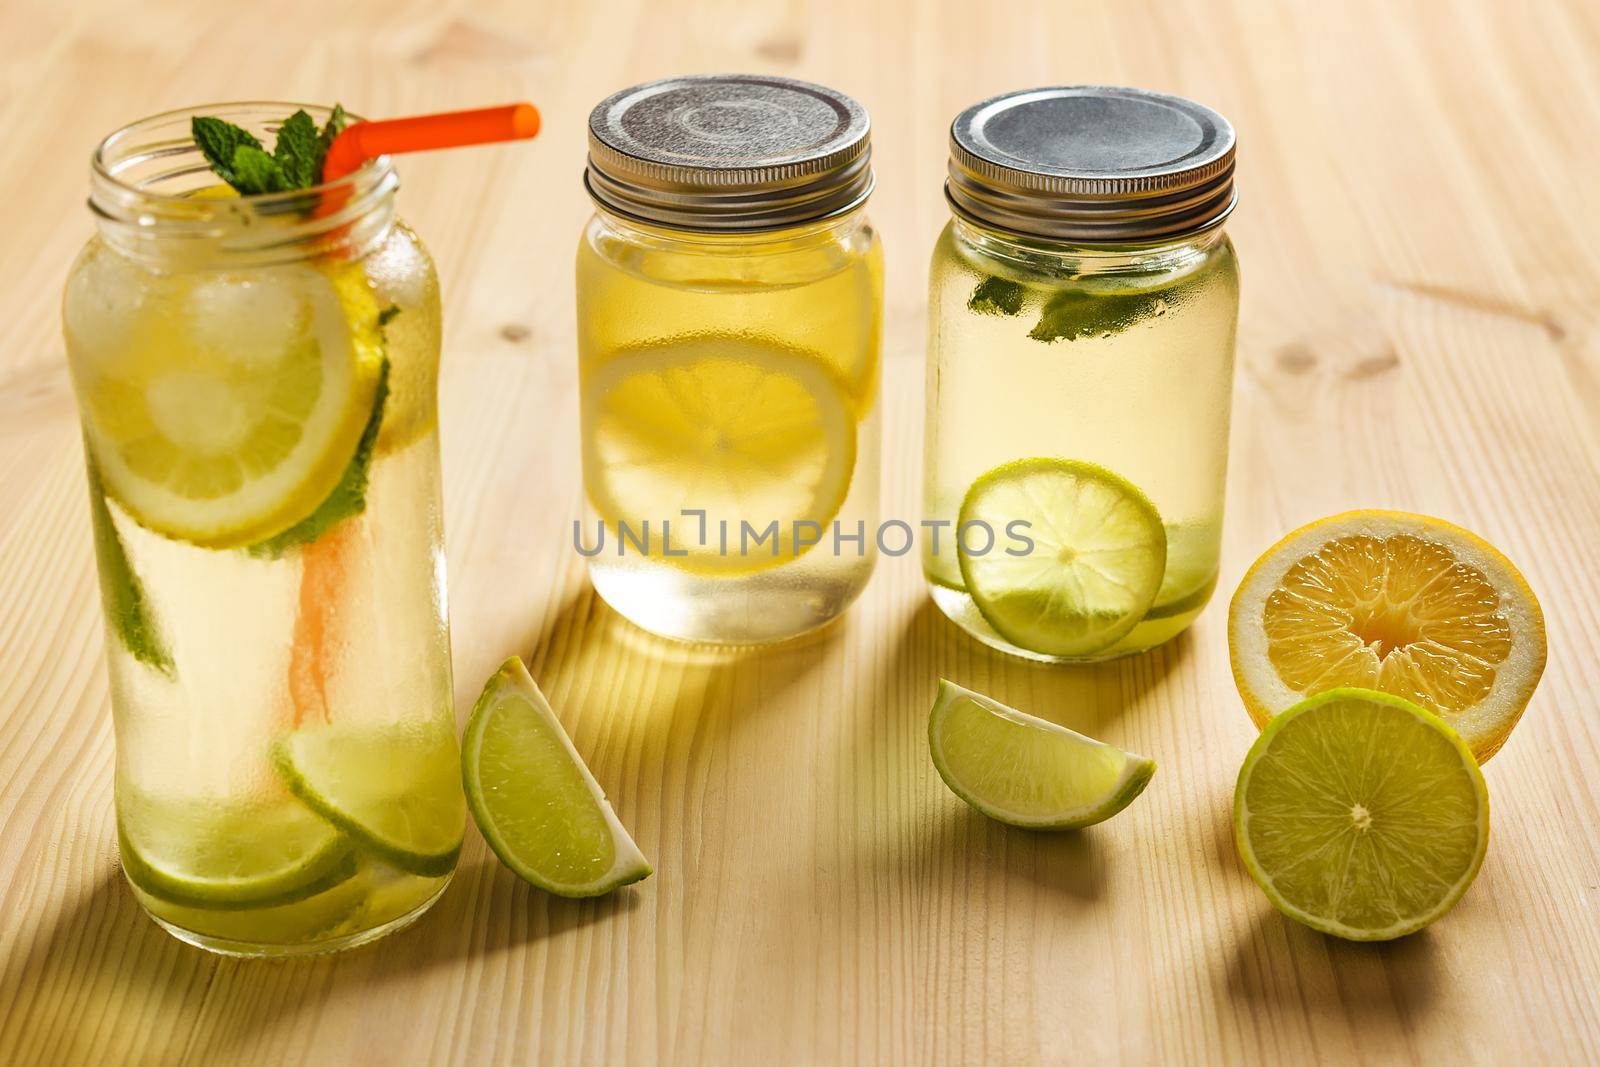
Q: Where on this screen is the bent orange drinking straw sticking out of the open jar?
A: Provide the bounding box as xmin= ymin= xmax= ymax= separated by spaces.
xmin=317 ymin=102 xmax=539 ymax=214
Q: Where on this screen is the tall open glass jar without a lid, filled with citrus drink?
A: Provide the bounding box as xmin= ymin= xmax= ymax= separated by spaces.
xmin=64 ymin=104 xmax=466 ymax=955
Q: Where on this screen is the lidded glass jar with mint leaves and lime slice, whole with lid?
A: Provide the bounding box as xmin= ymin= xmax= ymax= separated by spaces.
xmin=922 ymin=86 xmax=1238 ymax=662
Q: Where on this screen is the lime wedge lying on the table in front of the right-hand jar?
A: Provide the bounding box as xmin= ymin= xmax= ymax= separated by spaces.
xmin=928 ymin=680 xmax=1155 ymax=830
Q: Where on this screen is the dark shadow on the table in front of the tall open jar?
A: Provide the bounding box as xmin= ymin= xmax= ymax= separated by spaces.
xmin=0 ymin=857 xmax=638 ymax=1064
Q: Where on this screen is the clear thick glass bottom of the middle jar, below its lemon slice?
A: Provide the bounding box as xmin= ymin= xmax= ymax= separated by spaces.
xmin=589 ymin=557 xmax=875 ymax=646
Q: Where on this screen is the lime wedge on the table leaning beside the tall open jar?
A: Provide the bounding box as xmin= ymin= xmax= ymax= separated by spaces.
xmin=461 ymin=657 xmax=651 ymax=897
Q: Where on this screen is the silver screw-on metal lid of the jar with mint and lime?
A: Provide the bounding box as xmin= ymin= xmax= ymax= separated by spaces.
xmin=944 ymin=85 xmax=1235 ymax=245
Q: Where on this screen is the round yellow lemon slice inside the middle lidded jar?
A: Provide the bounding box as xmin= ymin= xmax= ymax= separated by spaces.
xmin=582 ymin=334 xmax=856 ymax=574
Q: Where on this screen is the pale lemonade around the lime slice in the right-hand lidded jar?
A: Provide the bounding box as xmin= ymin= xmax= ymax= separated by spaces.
xmin=923 ymin=221 xmax=1238 ymax=657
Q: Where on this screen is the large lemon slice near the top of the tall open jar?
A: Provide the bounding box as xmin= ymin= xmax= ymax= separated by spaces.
xmin=76 ymin=264 xmax=382 ymax=547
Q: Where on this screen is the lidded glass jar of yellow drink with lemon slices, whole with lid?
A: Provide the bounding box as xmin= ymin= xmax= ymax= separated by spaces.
xmin=573 ymin=75 xmax=883 ymax=645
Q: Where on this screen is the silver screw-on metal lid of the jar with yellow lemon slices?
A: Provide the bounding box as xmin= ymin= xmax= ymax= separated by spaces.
xmin=584 ymin=74 xmax=872 ymax=232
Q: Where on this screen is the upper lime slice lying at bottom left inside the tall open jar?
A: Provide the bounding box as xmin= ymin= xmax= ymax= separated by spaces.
xmin=117 ymin=789 xmax=355 ymax=910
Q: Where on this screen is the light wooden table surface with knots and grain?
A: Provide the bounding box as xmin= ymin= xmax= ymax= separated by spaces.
xmin=0 ymin=0 xmax=1600 ymax=1065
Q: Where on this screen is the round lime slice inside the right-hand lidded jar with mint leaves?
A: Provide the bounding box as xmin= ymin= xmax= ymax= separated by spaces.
xmin=957 ymin=458 xmax=1166 ymax=656
